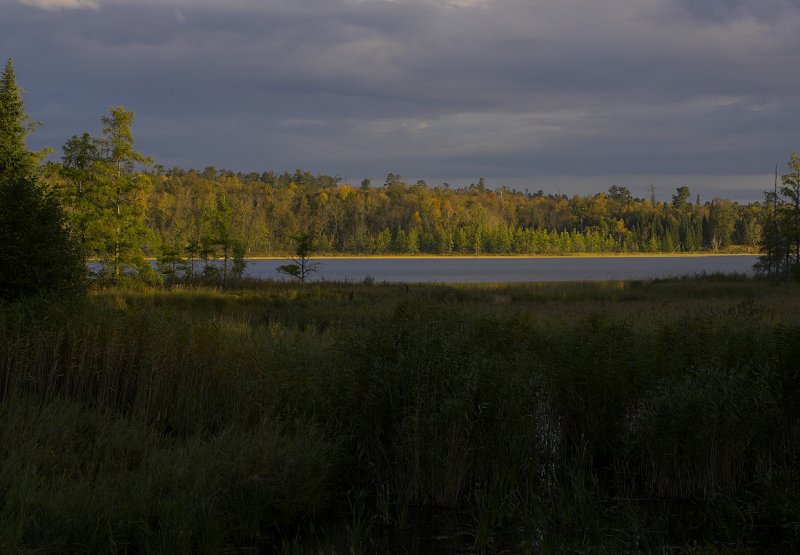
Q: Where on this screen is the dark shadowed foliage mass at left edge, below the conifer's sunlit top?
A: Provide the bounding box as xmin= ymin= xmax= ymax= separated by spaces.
xmin=0 ymin=179 xmax=85 ymax=301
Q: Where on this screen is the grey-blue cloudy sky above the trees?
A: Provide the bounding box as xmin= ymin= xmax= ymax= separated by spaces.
xmin=0 ymin=0 xmax=800 ymax=201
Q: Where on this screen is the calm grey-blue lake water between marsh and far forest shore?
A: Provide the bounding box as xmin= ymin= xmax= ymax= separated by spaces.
xmin=247 ymin=256 xmax=757 ymax=283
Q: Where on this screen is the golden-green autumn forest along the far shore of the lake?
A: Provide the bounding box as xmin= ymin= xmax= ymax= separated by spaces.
xmin=47 ymin=157 xmax=762 ymax=262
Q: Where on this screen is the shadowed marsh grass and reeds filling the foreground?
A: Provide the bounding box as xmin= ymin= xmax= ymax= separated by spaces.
xmin=0 ymin=277 xmax=800 ymax=553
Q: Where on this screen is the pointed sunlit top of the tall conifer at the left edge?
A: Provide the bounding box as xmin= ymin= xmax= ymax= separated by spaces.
xmin=0 ymin=58 xmax=37 ymax=183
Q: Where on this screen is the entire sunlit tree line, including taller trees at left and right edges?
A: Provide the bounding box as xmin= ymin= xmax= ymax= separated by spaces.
xmin=0 ymin=56 xmax=800 ymax=298
